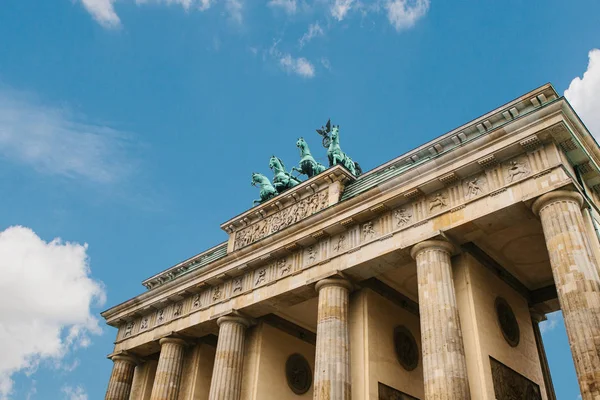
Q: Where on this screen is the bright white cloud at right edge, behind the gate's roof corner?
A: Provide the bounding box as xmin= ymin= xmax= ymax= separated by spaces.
xmin=565 ymin=49 xmax=600 ymax=141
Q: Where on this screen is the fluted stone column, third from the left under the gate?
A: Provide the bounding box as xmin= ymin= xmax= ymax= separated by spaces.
xmin=208 ymin=316 xmax=250 ymax=400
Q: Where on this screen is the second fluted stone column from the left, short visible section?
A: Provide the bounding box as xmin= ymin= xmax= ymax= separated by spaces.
xmin=150 ymin=337 xmax=186 ymax=400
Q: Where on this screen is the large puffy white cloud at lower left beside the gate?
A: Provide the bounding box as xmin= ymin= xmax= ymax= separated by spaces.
xmin=0 ymin=226 xmax=106 ymax=400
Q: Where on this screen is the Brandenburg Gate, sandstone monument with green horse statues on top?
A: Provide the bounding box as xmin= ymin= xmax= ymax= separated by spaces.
xmin=102 ymin=85 xmax=600 ymax=400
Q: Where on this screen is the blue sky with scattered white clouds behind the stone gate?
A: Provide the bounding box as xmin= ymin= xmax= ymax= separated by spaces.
xmin=0 ymin=0 xmax=600 ymax=400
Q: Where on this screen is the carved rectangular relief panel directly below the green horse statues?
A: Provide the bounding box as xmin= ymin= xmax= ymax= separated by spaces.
xmin=234 ymin=190 xmax=329 ymax=250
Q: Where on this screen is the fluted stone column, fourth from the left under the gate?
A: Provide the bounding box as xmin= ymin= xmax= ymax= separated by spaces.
xmin=313 ymin=279 xmax=352 ymax=400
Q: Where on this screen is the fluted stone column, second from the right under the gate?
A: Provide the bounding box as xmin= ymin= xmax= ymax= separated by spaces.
xmin=411 ymin=240 xmax=471 ymax=400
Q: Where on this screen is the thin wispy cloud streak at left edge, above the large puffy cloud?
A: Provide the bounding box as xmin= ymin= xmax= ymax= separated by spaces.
xmin=0 ymin=86 xmax=132 ymax=183
